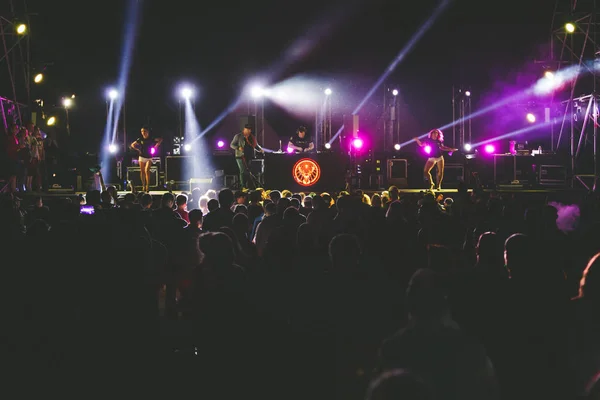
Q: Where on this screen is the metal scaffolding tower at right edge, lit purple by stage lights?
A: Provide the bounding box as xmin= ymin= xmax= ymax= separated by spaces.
xmin=549 ymin=0 xmax=600 ymax=190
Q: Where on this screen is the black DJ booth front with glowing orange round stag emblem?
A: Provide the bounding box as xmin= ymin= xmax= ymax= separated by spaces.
xmin=263 ymin=152 xmax=350 ymax=192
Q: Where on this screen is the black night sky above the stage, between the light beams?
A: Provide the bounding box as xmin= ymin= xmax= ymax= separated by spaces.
xmin=0 ymin=0 xmax=554 ymax=151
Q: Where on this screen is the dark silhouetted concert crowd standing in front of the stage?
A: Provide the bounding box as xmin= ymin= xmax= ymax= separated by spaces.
xmin=0 ymin=186 xmax=600 ymax=400
